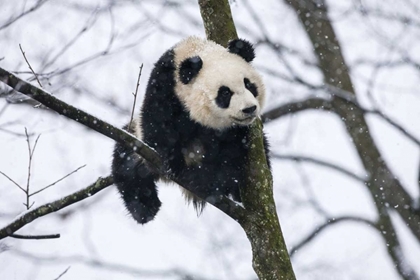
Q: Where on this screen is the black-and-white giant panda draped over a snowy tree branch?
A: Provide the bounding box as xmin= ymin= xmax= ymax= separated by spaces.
xmin=112 ymin=37 xmax=268 ymax=224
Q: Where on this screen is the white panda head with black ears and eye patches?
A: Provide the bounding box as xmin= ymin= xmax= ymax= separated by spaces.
xmin=174 ymin=37 xmax=265 ymax=130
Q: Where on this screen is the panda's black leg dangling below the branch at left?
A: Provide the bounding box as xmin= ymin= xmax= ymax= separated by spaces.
xmin=112 ymin=137 xmax=161 ymax=224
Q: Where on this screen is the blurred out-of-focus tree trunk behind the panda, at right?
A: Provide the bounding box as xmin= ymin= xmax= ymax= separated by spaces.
xmin=285 ymin=0 xmax=420 ymax=280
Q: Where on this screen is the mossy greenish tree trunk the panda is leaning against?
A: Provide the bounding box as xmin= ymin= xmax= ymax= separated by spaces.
xmin=199 ymin=0 xmax=296 ymax=280
